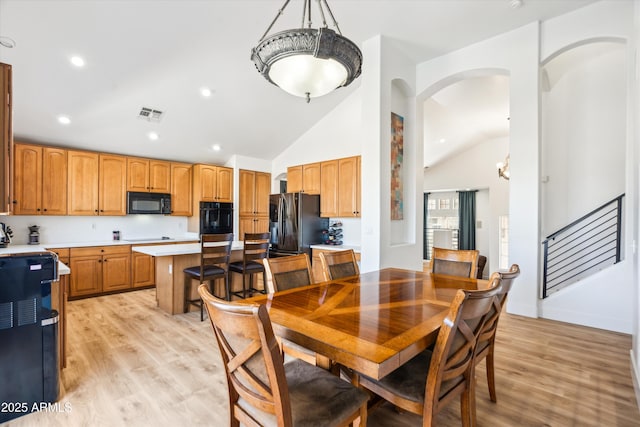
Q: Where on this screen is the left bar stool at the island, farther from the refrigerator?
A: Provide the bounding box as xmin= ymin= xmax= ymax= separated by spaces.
xmin=183 ymin=233 xmax=233 ymax=321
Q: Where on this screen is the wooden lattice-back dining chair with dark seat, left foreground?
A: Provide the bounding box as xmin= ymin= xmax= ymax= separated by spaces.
xmin=198 ymin=285 xmax=369 ymax=427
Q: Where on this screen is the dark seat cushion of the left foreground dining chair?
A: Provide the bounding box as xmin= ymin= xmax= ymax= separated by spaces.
xmin=238 ymin=360 xmax=369 ymax=427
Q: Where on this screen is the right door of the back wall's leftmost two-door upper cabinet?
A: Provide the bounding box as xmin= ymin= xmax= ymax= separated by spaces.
xmin=42 ymin=147 xmax=67 ymax=215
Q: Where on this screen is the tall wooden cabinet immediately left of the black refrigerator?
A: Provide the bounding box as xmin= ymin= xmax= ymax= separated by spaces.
xmin=237 ymin=169 xmax=271 ymax=240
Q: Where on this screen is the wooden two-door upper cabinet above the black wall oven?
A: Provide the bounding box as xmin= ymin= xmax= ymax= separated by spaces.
xmin=193 ymin=164 xmax=233 ymax=204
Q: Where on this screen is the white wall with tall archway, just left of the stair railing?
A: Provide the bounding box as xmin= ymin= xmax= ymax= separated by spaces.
xmin=416 ymin=23 xmax=539 ymax=317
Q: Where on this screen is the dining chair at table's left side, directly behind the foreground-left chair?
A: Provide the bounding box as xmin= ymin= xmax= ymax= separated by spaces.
xmin=267 ymin=253 xmax=318 ymax=365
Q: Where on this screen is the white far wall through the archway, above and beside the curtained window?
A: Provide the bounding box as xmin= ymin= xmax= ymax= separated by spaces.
xmin=424 ymin=138 xmax=515 ymax=275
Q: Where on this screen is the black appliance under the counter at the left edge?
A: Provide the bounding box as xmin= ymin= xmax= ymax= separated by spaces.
xmin=0 ymin=252 xmax=59 ymax=423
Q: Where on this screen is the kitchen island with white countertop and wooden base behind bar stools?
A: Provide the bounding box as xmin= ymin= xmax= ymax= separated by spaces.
xmin=132 ymin=242 xmax=250 ymax=314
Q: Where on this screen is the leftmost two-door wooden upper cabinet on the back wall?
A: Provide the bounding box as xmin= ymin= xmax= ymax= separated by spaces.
xmin=13 ymin=142 xmax=67 ymax=215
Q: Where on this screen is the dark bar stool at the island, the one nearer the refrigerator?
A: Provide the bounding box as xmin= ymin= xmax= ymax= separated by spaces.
xmin=229 ymin=233 xmax=271 ymax=298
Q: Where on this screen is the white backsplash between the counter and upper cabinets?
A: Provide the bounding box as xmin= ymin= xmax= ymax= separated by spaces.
xmin=0 ymin=215 xmax=190 ymax=245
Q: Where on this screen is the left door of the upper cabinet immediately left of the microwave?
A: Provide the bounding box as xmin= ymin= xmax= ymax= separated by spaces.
xmin=67 ymin=150 xmax=98 ymax=216
